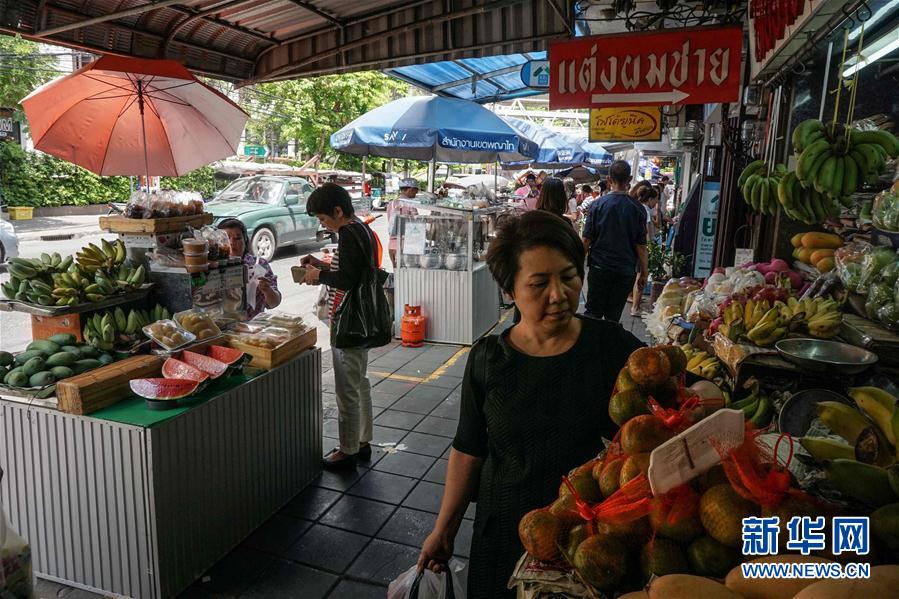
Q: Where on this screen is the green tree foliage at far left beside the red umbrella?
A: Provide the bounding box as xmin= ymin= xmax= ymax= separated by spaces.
xmin=0 ymin=35 xmax=58 ymax=122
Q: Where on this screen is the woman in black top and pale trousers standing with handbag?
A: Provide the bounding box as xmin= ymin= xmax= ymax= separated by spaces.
xmin=300 ymin=183 xmax=380 ymax=469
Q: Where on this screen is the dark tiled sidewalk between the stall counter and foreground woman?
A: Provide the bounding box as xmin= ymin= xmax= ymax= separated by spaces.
xmin=38 ymin=306 xmax=646 ymax=599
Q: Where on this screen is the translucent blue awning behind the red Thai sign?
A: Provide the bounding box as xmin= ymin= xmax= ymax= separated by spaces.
xmin=384 ymin=52 xmax=546 ymax=104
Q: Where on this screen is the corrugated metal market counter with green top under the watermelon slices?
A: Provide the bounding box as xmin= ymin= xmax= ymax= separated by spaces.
xmin=0 ymin=348 xmax=322 ymax=598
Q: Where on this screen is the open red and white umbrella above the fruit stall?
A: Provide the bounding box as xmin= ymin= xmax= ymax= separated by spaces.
xmin=21 ymin=56 xmax=247 ymax=188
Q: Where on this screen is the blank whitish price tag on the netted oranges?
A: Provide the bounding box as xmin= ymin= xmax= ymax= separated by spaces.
xmin=647 ymin=409 xmax=746 ymax=495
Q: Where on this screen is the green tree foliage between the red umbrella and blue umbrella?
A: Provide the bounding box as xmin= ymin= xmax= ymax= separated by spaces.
xmin=241 ymin=72 xmax=408 ymax=168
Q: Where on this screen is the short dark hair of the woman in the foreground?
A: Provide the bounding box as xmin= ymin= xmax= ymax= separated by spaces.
xmin=487 ymin=210 xmax=586 ymax=295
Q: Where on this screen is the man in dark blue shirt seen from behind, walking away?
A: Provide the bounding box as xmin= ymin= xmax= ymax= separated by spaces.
xmin=584 ymin=160 xmax=647 ymax=322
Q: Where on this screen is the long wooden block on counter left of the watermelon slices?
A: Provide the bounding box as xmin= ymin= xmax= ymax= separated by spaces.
xmin=56 ymin=355 xmax=165 ymax=416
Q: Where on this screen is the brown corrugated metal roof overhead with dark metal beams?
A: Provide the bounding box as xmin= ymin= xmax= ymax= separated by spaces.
xmin=0 ymin=0 xmax=574 ymax=84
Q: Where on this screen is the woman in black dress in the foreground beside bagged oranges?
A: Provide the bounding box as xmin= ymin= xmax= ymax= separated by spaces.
xmin=418 ymin=211 xmax=642 ymax=599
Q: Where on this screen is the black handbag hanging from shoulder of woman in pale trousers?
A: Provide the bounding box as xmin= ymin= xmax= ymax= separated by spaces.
xmin=334 ymin=227 xmax=393 ymax=349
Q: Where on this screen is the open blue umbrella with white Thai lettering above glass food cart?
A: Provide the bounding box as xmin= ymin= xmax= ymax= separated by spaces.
xmin=331 ymin=96 xmax=537 ymax=163
